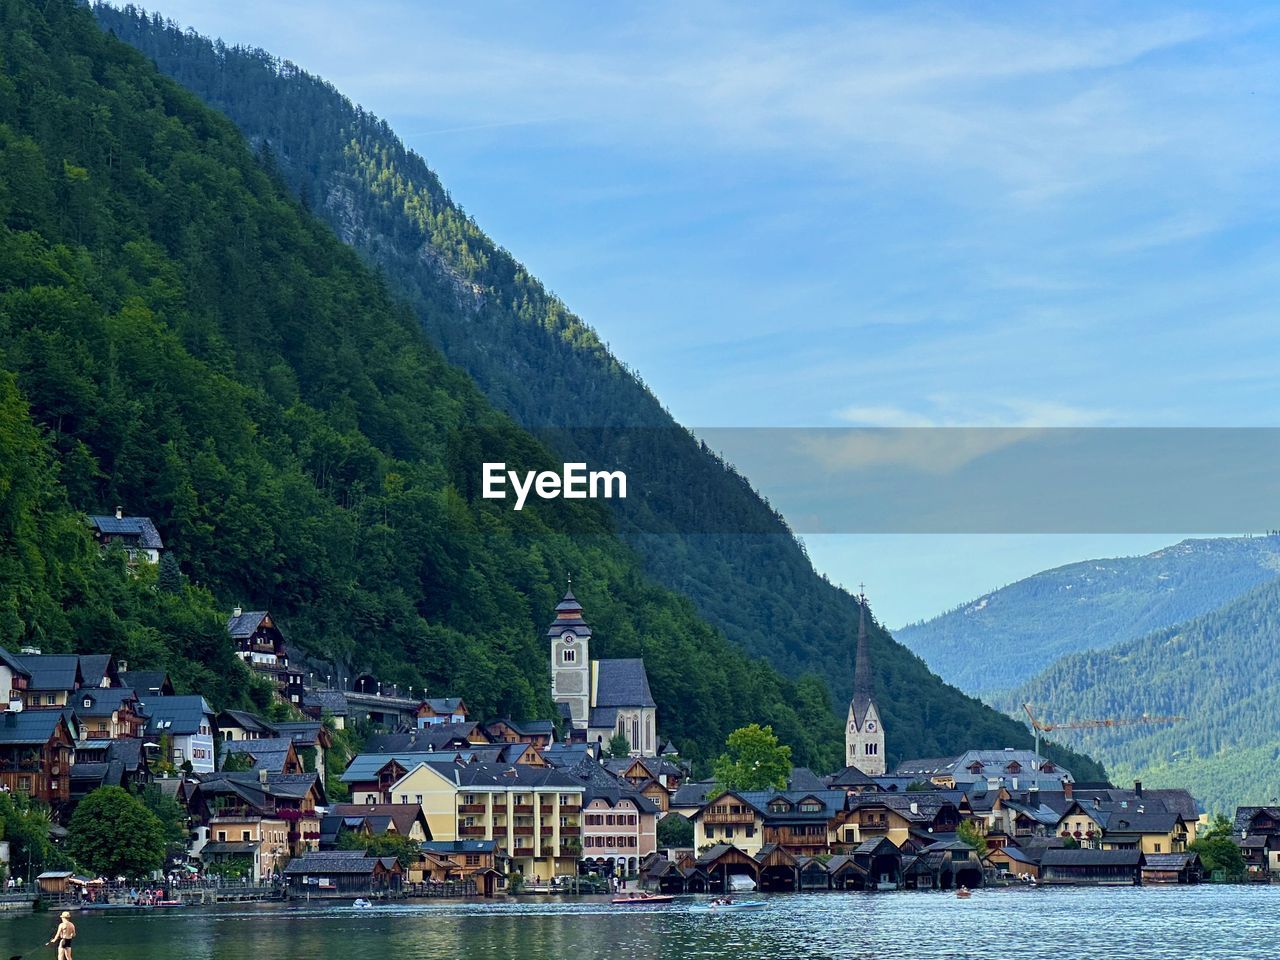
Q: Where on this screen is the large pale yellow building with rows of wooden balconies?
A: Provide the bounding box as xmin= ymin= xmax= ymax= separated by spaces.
xmin=389 ymin=763 xmax=584 ymax=881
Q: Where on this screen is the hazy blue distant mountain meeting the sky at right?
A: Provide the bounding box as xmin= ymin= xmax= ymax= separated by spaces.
xmin=897 ymin=536 xmax=1280 ymax=695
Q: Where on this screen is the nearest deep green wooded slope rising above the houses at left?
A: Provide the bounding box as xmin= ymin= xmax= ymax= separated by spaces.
xmin=0 ymin=0 xmax=865 ymax=767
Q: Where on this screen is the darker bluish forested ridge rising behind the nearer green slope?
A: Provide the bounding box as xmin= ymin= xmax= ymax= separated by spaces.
xmin=85 ymin=6 xmax=1111 ymax=769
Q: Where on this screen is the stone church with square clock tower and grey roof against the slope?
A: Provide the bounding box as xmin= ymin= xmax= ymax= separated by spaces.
xmin=547 ymin=589 xmax=658 ymax=756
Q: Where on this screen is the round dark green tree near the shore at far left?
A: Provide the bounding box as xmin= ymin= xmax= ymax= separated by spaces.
xmin=67 ymin=787 xmax=165 ymax=879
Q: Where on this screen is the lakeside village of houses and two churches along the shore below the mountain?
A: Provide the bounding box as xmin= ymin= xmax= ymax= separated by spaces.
xmin=0 ymin=511 xmax=1259 ymax=909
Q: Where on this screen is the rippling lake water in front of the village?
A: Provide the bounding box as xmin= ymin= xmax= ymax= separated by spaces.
xmin=0 ymin=886 xmax=1280 ymax=960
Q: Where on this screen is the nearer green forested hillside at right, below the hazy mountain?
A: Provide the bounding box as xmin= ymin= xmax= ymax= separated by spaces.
xmin=1001 ymin=579 xmax=1280 ymax=812
